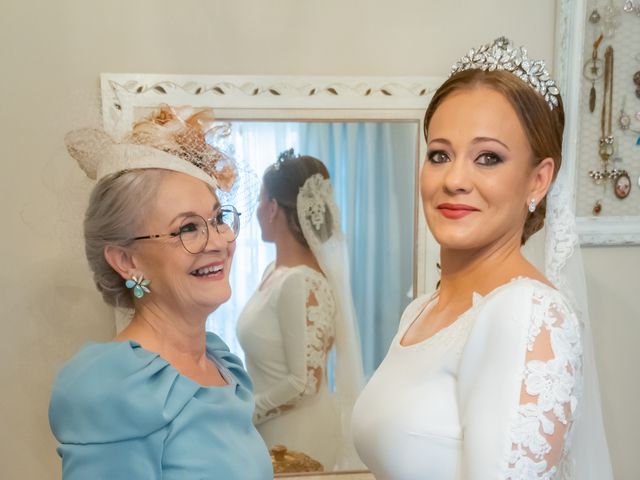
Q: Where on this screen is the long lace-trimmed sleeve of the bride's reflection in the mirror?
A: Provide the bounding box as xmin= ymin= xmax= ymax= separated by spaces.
xmin=254 ymin=275 xmax=335 ymax=424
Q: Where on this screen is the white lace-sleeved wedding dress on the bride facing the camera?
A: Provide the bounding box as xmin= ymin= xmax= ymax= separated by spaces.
xmin=353 ymin=278 xmax=582 ymax=480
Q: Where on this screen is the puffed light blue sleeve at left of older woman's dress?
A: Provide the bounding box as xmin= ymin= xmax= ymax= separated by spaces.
xmin=49 ymin=342 xmax=195 ymax=480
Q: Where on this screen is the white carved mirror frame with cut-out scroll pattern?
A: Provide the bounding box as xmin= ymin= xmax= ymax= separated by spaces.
xmin=101 ymin=73 xmax=443 ymax=298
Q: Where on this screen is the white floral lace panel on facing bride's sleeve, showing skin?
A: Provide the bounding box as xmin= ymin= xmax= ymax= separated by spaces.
xmin=504 ymin=286 xmax=582 ymax=480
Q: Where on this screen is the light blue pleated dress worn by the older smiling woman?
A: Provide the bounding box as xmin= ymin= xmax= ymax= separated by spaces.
xmin=49 ymin=333 xmax=273 ymax=480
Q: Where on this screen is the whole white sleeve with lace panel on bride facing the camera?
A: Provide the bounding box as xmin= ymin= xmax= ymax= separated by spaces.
xmin=457 ymin=279 xmax=582 ymax=480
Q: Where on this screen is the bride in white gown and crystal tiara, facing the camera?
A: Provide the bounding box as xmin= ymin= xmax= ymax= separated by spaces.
xmin=354 ymin=38 xmax=611 ymax=480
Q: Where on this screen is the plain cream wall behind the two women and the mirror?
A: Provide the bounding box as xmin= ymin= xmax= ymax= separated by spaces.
xmin=0 ymin=0 xmax=640 ymax=480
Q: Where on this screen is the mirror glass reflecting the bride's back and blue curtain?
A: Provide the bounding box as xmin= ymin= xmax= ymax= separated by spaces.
xmin=208 ymin=121 xmax=418 ymax=470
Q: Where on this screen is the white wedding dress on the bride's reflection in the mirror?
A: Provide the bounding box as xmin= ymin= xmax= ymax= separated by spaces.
xmin=238 ymin=264 xmax=341 ymax=470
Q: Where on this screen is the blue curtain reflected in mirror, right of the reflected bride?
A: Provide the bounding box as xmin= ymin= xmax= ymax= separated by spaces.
xmin=301 ymin=122 xmax=417 ymax=376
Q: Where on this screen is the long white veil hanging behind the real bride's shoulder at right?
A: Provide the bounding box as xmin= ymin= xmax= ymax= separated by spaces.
xmin=545 ymin=163 xmax=613 ymax=480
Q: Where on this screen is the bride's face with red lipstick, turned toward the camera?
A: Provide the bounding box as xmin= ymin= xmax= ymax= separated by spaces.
xmin=420 ymin=87 xmax=540 ymax=250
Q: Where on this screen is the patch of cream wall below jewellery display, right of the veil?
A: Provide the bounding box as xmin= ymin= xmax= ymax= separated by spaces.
xmin=583 ymin=248 xmax=640 ymax=480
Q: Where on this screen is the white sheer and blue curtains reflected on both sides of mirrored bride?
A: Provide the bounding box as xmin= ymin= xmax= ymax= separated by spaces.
xmin=209 ymin=122 xmax=418 ymax=376
